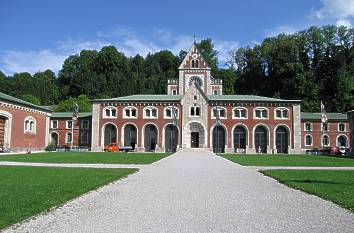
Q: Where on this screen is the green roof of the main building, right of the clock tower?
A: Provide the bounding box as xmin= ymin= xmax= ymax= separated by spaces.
xmin=208 ymin=95 xmax=301 ymax=102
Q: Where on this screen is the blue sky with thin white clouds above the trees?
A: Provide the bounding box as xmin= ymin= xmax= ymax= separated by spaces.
xmin=0 ymin=0 xmax=354 ymax=75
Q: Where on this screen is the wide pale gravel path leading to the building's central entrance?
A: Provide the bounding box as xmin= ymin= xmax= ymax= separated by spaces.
xmin=6 ymin=150 xmax=354 ymax=233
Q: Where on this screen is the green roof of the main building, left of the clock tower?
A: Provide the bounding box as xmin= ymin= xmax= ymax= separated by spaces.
xmin=93 ymin=95 xmax=182 ymax=102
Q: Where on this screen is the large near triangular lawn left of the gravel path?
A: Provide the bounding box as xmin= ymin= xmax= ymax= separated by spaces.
xmin=0 ymin=166 xmax=137 ymax=229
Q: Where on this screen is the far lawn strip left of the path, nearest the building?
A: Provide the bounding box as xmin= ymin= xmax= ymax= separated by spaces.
xmin=0 ymin=152 xmax=171 ymax=164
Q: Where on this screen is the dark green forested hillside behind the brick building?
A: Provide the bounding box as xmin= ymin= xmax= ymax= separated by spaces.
xmin=0 ymin=26 xmax=354 ymax=112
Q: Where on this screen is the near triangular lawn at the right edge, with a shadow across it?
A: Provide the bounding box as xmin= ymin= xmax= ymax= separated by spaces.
xmin=262 ymin=170 xmax=354 ymax=212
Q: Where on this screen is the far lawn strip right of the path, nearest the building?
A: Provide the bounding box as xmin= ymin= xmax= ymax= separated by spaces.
xmin=224 ymin=154 xmax=354 ymax=167
